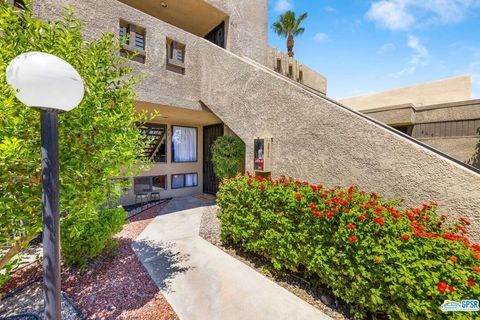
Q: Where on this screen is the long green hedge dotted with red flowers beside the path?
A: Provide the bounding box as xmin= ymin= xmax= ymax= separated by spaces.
xmin=217 ymin=176 xmax=480 ymax=319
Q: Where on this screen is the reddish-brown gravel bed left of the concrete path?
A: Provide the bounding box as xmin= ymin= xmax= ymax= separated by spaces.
xmin=0 ymin=203 xmax=178 ymax=320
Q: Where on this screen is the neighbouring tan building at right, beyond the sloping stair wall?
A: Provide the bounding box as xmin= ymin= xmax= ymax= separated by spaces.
xmin=340 ymin=76 xmax=480 ymax=168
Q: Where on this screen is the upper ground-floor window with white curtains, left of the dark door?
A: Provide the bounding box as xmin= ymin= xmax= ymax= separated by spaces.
xmin=172 ymin=126 xmax=198 ymax=162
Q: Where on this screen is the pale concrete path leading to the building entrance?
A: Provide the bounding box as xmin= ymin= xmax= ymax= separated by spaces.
xmin=132 ymin=197 xmax=330 ymax=320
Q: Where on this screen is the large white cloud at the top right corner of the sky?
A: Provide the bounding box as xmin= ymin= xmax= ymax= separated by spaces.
xmin=367 ymin=0 xmax=480 ymax=30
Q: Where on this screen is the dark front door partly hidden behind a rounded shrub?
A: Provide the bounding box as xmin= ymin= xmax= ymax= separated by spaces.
xmin=203 ymin=124 xmax=223 ymax=194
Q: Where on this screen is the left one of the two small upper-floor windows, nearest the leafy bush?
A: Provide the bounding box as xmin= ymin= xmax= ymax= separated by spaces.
xmin=119 ymin=20 xmax=145 ymax=63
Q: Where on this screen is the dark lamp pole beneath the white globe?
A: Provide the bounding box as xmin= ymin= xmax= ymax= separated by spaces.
xmin=40 ymin=110 xmax=61 ymax=320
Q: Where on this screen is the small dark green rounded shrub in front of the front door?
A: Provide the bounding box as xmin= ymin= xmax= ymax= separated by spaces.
xmin=212 ymin=136 xmax=245 ymax=179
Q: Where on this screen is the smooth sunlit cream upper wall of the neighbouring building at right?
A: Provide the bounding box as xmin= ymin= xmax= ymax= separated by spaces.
xmin=339 ymin=76 xmax=471 ymax=111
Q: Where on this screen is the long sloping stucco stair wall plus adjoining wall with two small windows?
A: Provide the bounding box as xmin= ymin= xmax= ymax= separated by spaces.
xmin=36 ymin=0 xmax=480 ymax=240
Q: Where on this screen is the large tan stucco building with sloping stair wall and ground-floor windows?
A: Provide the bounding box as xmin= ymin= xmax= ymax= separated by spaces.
xmin=33 ymin=0 xmax=480 ymax=238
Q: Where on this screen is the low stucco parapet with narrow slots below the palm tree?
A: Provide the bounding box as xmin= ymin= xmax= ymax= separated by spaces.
xmin=267 ymin=46 xmax=327 ymax=94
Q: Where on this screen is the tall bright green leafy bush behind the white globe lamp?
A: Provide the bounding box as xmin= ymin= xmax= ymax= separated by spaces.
xmin=0 ymin=1 xmax=148 ymax=283
